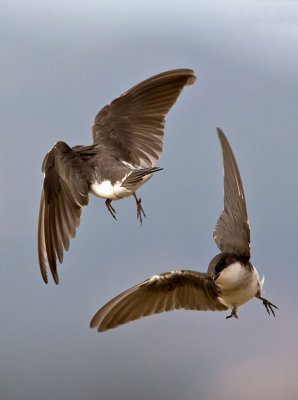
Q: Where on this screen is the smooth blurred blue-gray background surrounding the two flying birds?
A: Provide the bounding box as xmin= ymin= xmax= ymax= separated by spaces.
xmin=0 ymin=0 xmax=298 ymax=400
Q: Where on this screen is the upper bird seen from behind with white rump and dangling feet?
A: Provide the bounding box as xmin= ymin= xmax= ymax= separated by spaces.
xmin=38 ymin=69 xmax=196 ymax=284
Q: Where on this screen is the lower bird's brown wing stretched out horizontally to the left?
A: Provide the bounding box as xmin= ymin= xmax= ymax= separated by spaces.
xmin=90 ymin=270 xmax=228 ymax=332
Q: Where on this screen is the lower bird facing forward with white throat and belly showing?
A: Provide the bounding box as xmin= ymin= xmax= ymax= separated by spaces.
xmin=90 ymin=128 xmax=277 ymax=332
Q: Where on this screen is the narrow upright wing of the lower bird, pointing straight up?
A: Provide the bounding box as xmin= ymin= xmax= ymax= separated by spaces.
xmin=213 ymin=128 xmax=250 ymax=259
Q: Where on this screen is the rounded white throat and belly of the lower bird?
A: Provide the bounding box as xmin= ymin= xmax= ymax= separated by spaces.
xmin=216 ymin=262 xmax=261 ymax=307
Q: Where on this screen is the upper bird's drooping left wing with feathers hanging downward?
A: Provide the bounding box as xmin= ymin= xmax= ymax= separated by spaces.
xmin=38 ymin=142 xmax=94 ymax=284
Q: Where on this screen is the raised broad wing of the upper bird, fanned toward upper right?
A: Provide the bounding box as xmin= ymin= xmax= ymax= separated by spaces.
xmin=92 ymin=69 xmax=196 ymax=168
